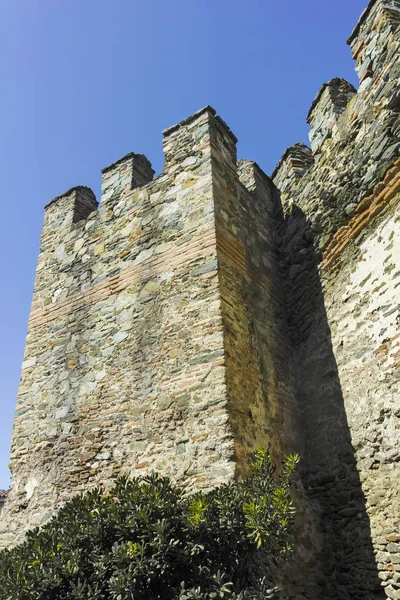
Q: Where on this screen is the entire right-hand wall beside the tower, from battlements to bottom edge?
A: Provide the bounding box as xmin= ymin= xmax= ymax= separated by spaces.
xmin=273 ymin=0 xmax=400 ymax=599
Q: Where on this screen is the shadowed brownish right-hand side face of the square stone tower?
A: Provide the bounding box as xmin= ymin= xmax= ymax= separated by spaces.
xmin=214 ymin=161 xmax=298 ymax=473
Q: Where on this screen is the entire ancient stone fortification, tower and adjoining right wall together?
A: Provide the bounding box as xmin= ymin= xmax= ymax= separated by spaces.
xmin=1 ymin=0 xmax=400 ymax=600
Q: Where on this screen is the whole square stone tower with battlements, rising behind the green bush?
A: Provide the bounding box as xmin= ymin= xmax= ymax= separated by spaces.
xmin=1 ymin=107 xmax=298 ymax=545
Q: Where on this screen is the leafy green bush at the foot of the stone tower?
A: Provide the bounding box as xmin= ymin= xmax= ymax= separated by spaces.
xmin=0 ymin=450 xmax=298 ymax=600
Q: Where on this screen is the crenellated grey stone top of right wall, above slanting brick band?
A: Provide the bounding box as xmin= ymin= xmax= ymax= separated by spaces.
xmin=273 ymin=0 xmax=400 ymax=250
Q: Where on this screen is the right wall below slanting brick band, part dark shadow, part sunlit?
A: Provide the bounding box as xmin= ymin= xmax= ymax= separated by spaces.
xmin=287 ymin=189 xmax=400 ymax=599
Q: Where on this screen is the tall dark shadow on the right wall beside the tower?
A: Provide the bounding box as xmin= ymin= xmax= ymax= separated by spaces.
xmin=281 ymin=206 xmax=386 ymax=600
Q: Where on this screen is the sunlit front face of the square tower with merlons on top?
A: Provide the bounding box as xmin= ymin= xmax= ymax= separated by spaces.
xmin=3 ymin=108 xmax=296 ymax=556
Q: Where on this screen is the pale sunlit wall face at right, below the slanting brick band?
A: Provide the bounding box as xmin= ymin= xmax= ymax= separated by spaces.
xmin=323 ymin=185 xmax=400 ymax=597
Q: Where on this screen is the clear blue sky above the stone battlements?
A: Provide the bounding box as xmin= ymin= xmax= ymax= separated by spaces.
xmin=0 ymin=0 xmax=367 ymax=488
